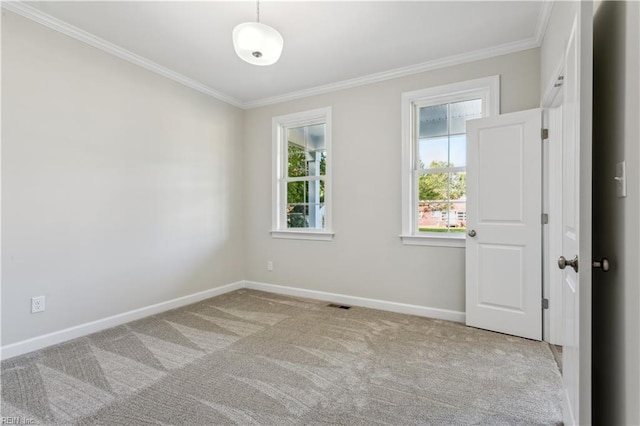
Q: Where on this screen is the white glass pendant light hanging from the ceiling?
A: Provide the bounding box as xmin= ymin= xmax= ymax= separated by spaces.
xmin=233 ymin=0 xmax=284 ymax=65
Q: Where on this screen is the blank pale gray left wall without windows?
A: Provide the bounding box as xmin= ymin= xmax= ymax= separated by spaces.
xmin=2 ymin=11 xmax=244 ymax=345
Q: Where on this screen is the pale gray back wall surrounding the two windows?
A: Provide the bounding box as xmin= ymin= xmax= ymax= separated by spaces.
xmin=245 ymin=49 xmax=540 ymax=312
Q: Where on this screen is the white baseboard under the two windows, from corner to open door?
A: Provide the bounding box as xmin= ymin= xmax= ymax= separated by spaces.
xmin=244 ymin=281 xmax=465 ymax=324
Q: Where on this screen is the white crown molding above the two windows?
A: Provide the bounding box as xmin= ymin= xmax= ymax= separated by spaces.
xmin=244 ymin=37 xmax=540 ymax=109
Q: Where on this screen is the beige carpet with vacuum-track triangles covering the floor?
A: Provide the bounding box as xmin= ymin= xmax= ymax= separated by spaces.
xmin=1 ymin=290 xmax=562 ymax=426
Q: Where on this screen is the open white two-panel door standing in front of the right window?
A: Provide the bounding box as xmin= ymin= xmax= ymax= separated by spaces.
xmin=466 ymin=109 xmax=542 ymax=340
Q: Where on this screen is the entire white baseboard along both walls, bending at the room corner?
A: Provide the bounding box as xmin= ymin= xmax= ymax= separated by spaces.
xmin=0 ymin=281 xmax=465 ymax=360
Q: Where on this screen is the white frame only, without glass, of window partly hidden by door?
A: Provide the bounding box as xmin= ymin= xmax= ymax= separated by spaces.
xmin=400 ymin=75 xmax=500 ymax=247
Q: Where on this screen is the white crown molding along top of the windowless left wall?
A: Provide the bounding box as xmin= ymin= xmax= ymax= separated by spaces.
xmin=1 ymin=1 xmax=244 ymax=108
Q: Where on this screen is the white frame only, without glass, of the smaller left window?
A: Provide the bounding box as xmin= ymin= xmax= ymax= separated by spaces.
xmin=270 ymin=107 xmax=334 ymax=241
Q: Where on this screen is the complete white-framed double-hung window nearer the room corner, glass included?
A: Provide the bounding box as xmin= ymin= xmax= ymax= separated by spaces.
xmin=271 ymin=108 xmax=333 ymax=240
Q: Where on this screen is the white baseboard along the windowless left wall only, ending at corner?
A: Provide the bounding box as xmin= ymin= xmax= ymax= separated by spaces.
xmin=0 ymin=281 xmax=244 ymax=360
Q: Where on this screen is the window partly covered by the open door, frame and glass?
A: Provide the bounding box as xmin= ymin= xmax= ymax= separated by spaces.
xmin=401 ymin=76 xmax=499 ymax=247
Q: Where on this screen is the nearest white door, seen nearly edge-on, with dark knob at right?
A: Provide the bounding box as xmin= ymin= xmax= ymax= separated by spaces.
xmin=558 ymin=2 xmax=593 ymax=425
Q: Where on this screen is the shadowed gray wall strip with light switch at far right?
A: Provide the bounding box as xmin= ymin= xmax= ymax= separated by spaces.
xmin=593 ymin=1 xmax=640 ymax=425
